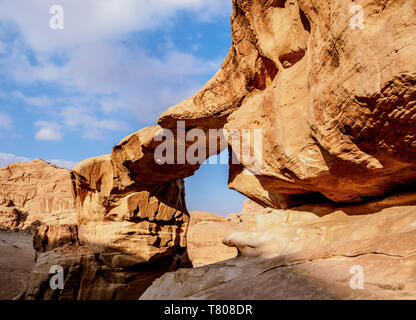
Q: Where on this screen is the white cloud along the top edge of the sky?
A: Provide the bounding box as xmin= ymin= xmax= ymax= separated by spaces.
xmin=0 ymin=0 xmax=231 ymax=52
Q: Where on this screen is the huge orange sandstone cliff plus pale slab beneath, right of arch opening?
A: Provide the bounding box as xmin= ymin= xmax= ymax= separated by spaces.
xmin=141 ymin=0 xmax=416 ymax=299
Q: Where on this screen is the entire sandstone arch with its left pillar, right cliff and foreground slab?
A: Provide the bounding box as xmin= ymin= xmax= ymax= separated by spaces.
xmin=9 ymin=0 xmax=416 ymax=299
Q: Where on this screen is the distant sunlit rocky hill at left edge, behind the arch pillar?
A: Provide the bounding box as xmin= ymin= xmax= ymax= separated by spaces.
xmin=0 ymin=159 xmax=76 ymax=229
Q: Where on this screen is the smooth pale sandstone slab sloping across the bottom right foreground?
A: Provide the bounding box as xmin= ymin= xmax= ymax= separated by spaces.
xmin=141 ymin=194 xmax=416 ymax=300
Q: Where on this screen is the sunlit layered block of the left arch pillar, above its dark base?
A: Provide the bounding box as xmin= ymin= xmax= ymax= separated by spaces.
xmin=73 ymin=152 xmax=189 ymax=263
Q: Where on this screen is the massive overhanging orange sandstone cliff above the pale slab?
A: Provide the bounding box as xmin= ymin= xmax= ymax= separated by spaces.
xmin=159 ymin=0 xmax=416 ymax=208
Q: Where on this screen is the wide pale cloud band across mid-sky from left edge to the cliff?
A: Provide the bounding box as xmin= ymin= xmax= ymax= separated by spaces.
xmin=0 ymin=18 xmax=222 ymax=123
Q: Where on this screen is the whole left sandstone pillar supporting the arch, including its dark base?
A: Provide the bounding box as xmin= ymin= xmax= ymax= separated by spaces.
xmin=24 ymin=129 xmax=192 ymax=300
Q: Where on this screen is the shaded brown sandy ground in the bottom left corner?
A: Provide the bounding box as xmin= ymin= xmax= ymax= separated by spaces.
xmin=0 ymin=231 xmax=35 ymax=300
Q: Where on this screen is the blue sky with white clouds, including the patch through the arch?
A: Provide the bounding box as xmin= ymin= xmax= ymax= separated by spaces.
xmin=0 ymin=0 xmax=244 ymax=215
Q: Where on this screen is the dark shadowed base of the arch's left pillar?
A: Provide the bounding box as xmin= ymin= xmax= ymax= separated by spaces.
xmin=23 ymin=225 xmax=189 ymax=300
